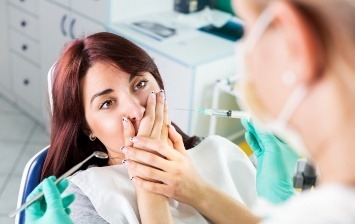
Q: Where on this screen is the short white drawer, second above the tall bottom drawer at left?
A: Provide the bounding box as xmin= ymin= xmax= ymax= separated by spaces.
xmin=9 ymin=7 xmax=38 ymax=39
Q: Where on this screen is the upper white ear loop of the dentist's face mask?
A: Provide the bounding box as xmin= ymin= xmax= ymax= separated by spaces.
xmin=245 ymin=8 xmax=275 ymax=53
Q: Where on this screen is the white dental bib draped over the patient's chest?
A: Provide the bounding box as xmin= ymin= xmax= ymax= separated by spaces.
xmin=70 ymin=136 xmax=257 ymax=224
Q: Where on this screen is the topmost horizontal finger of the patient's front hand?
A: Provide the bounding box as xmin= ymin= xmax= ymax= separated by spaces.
xmin=129 ymin=136 xmax=176 ymax=160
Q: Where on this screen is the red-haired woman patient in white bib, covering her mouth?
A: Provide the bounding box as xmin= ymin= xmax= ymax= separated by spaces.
xmin=42 ymin=33 xmax=256 ymax=223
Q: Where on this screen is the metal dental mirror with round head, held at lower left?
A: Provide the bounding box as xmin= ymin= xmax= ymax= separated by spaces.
xmin=9 ymin=151 xmax=108 ymax=218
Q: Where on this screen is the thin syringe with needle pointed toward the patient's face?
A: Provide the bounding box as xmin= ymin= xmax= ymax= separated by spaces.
xmin=174 ymin=108 xmax=250 ymax=120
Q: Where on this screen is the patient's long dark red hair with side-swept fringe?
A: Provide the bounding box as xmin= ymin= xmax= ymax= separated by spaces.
xmin=41 ymin=32 xmax=200 ymax=180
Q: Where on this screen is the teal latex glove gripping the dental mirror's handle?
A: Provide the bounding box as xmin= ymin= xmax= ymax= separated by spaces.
xmin=26 ymin=176 xmax=75 ymax=224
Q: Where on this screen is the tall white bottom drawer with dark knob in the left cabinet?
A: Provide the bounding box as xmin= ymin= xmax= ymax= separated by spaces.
xmin=11 ymin=54 xmax=43 ymax=111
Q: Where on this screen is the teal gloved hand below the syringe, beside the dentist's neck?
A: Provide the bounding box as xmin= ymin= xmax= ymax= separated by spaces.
xmin=242 ymin=119 xmax=298 ymax=204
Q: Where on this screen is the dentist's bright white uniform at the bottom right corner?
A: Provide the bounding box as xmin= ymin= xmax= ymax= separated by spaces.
xmin=257 ymin=184 xmax=355 ymax=224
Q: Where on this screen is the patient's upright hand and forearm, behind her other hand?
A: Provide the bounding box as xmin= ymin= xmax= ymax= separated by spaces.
xmin=122 ymin=91 xmax=173 ymax=224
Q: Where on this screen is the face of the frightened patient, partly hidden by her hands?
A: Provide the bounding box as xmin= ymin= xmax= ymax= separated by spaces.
xmin=80 ymin=62 xmax=160 ymax=153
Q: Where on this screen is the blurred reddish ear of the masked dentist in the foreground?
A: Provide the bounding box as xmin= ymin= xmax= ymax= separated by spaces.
xmin=270 ymin=1 xmax=324 ymax=83
